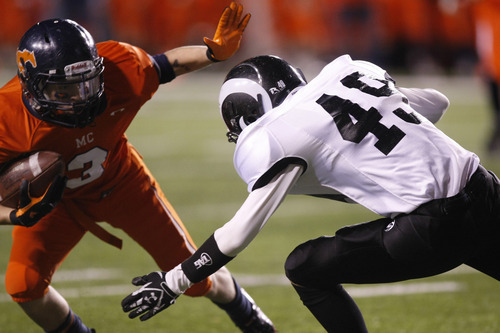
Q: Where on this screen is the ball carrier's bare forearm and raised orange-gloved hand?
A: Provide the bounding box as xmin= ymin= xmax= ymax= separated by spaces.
xmin=165 ymin=1 xmax=250 ymax=76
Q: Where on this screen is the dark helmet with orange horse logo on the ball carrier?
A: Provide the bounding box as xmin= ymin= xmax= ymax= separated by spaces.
xmin=17 ymin=19 xmax=106 ymax=128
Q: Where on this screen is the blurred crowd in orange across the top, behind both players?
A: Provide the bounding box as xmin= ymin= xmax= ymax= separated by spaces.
xmin=0 ymin=0 xmax=492 ymax=74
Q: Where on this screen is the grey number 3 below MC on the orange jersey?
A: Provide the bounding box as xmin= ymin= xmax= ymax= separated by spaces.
xmin=66 ymin=147 xmax=108 ymax=188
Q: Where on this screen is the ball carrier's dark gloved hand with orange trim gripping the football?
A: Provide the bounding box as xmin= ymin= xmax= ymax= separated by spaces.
xmin=9 ymin=175 xmax=67 ymax=227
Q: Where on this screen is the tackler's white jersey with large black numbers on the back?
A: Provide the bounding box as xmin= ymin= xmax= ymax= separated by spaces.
xmin=234 ymin=55 xmax=479 ymax=216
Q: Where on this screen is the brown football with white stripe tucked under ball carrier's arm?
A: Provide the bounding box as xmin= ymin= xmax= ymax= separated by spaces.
xmin=0 ymin=151 xmax=66 ymax=208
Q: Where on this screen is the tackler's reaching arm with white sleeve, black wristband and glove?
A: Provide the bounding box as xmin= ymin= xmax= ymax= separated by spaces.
xmin=122 ymin=165 xmax=303 ymax=320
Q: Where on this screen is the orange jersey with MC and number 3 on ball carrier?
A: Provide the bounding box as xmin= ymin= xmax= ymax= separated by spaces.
xmin=0 ymin=41 xmax=159 ymax=199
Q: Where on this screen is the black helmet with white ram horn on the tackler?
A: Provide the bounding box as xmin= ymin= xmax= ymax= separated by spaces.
xmin=219 ymin=55 xmax=307 ymax=142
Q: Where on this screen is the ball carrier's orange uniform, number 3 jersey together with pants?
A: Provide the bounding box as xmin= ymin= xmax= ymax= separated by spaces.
xmin=0 ymin=42 xmax=212 ymax=302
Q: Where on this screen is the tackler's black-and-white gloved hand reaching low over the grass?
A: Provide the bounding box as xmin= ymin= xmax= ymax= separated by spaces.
xmin=122 ymin=272 xmax=179 ymax=321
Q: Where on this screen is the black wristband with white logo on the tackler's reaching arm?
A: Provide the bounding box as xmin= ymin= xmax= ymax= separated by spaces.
xmin=181 ymin=235 xmax=233 ymax=283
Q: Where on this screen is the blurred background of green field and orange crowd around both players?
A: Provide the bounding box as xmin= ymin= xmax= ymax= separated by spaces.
xmin=0 ymin=0 xmax=500 ymax=333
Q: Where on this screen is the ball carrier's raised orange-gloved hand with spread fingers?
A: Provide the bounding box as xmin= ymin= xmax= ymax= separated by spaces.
xmin=203 ymin=1 xmax=251 ymax=61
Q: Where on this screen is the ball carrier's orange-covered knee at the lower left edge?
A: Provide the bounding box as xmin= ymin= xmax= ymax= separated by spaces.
xmin=5 ymin=262 xmax=49 ymax=302
